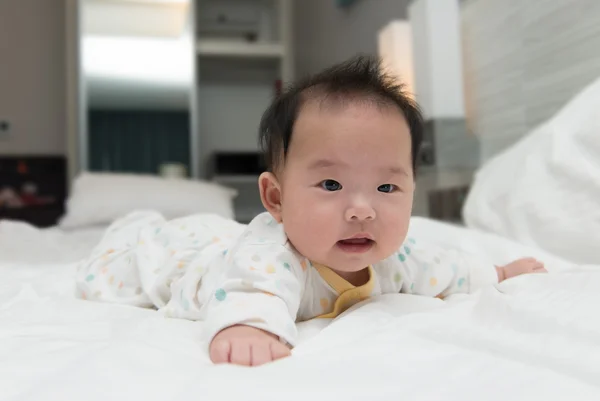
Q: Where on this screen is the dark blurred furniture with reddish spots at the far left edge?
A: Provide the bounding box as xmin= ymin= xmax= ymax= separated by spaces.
xmin=0 ymin=156 xmax=67 ymax=227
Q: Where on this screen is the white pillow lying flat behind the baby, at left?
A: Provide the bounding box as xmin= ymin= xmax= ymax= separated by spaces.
xmin=59 ymin=173 xmax=237 ymax=229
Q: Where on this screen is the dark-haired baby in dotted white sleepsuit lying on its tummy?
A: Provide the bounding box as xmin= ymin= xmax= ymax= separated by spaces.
xmin=77 ymin=57 xmax=546 ymax=365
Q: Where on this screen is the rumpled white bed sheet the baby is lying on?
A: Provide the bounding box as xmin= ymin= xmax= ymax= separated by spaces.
xmin=0 ymin=219 xmax=600 ymax=401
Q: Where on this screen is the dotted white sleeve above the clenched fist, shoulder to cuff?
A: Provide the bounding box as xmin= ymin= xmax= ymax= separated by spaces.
xmin=204 ymin=215 xmax=306 ymax=345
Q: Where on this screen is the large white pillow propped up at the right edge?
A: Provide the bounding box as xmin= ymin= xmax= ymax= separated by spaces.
xmin=463 ymin=75 xmax=600 ymax=264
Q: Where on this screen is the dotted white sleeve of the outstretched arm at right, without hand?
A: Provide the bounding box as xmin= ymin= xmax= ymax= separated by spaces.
xmin=384 ymin=239 xmax=498 ymax=298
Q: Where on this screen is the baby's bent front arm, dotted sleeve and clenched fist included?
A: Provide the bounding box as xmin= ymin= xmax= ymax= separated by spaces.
xmin=205 ymin=239 xmax=304 ymax=365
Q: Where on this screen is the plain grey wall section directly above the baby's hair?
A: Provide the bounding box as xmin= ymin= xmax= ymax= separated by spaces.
xmin=294 ymin=0 xmax=410 ymax=76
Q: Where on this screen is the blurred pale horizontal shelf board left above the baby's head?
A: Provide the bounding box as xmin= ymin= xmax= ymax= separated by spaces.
xmin=196 ymin=39 xmax=285 ymax=59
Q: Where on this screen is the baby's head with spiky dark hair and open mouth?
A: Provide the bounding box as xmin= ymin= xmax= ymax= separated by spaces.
xmin=259 ymin=57 xmax=423 ymax=279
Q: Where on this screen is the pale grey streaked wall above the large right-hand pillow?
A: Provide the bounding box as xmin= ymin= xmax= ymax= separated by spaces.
xmin=462 ymin=0 xmax=600 ymax=160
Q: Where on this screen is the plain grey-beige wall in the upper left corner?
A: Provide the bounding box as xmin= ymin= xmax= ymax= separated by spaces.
xmin=0 ymin=0 xmax=66 ymax=155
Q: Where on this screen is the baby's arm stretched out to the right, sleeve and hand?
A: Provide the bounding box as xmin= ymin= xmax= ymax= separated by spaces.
xmin=395 ymin=239 xmax=545 ymax=298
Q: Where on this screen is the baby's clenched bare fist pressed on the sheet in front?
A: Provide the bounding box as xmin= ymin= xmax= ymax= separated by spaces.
xmin=209 ymin=325 xmax=290 ymax=366
